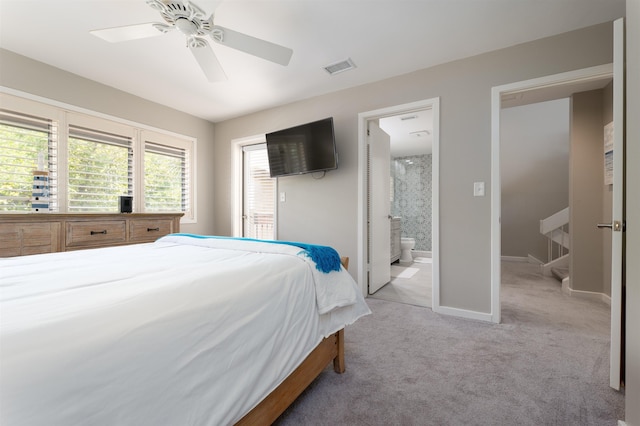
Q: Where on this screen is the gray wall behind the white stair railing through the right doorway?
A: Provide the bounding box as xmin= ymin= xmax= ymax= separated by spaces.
xmin=500 ymin=98 xmax=569 ymax=262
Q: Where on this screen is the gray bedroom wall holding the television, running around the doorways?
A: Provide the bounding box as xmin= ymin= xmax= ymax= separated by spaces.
xmin=214 ymin=24 xmax=612 ymax=313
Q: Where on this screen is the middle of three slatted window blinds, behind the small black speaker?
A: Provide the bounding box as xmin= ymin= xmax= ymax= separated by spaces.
xmin=67 ymin=125 xmax=133 ymax=213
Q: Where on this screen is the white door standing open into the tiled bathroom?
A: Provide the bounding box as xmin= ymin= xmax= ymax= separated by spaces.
xmin=367 ymin=120 xmax=391 ymax=294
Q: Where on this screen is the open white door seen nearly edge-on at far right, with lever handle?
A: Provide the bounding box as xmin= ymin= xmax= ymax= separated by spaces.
xmin=609 ymin=18 xmax=624 ymax=390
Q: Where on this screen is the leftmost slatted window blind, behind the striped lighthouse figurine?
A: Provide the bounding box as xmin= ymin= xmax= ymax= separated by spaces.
xmin=0 ymin=109 xmax=58 ymax=212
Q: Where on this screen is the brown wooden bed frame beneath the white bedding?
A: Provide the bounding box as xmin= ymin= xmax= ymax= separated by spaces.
xmin=236 ymin=257 xmax=349 ymax=426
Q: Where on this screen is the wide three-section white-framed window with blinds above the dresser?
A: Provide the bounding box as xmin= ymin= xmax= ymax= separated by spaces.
xmin=0 ymin=93 xmax=196 ymax=222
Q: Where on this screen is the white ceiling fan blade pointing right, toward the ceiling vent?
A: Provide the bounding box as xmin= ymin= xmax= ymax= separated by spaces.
xmin=211 ymin=25 xmax=293 ymax=66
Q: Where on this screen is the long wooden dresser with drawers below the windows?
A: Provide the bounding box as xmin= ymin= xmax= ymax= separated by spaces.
xmin=0 ymin=213 xmax=182 ymax=257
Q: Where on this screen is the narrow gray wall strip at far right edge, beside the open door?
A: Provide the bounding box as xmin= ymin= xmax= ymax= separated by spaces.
xmin=625 ymin=0 xmax=640 ymax=426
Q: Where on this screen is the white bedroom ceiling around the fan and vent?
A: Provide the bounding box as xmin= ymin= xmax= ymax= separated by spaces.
xmin=0 ymin=0 xmax=625 ymax=122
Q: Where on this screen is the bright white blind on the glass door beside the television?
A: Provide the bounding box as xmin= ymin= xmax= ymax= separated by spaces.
xmin=243 ymin=144 xmax=276 ymax=240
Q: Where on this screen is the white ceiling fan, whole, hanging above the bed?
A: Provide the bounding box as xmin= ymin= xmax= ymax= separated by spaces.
xmin=90 ymin=0 xmax=293 ymax=82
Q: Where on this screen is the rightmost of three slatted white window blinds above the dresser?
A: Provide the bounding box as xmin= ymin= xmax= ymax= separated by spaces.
xmin=144 ymin=142 xmax=190 ymax=212
